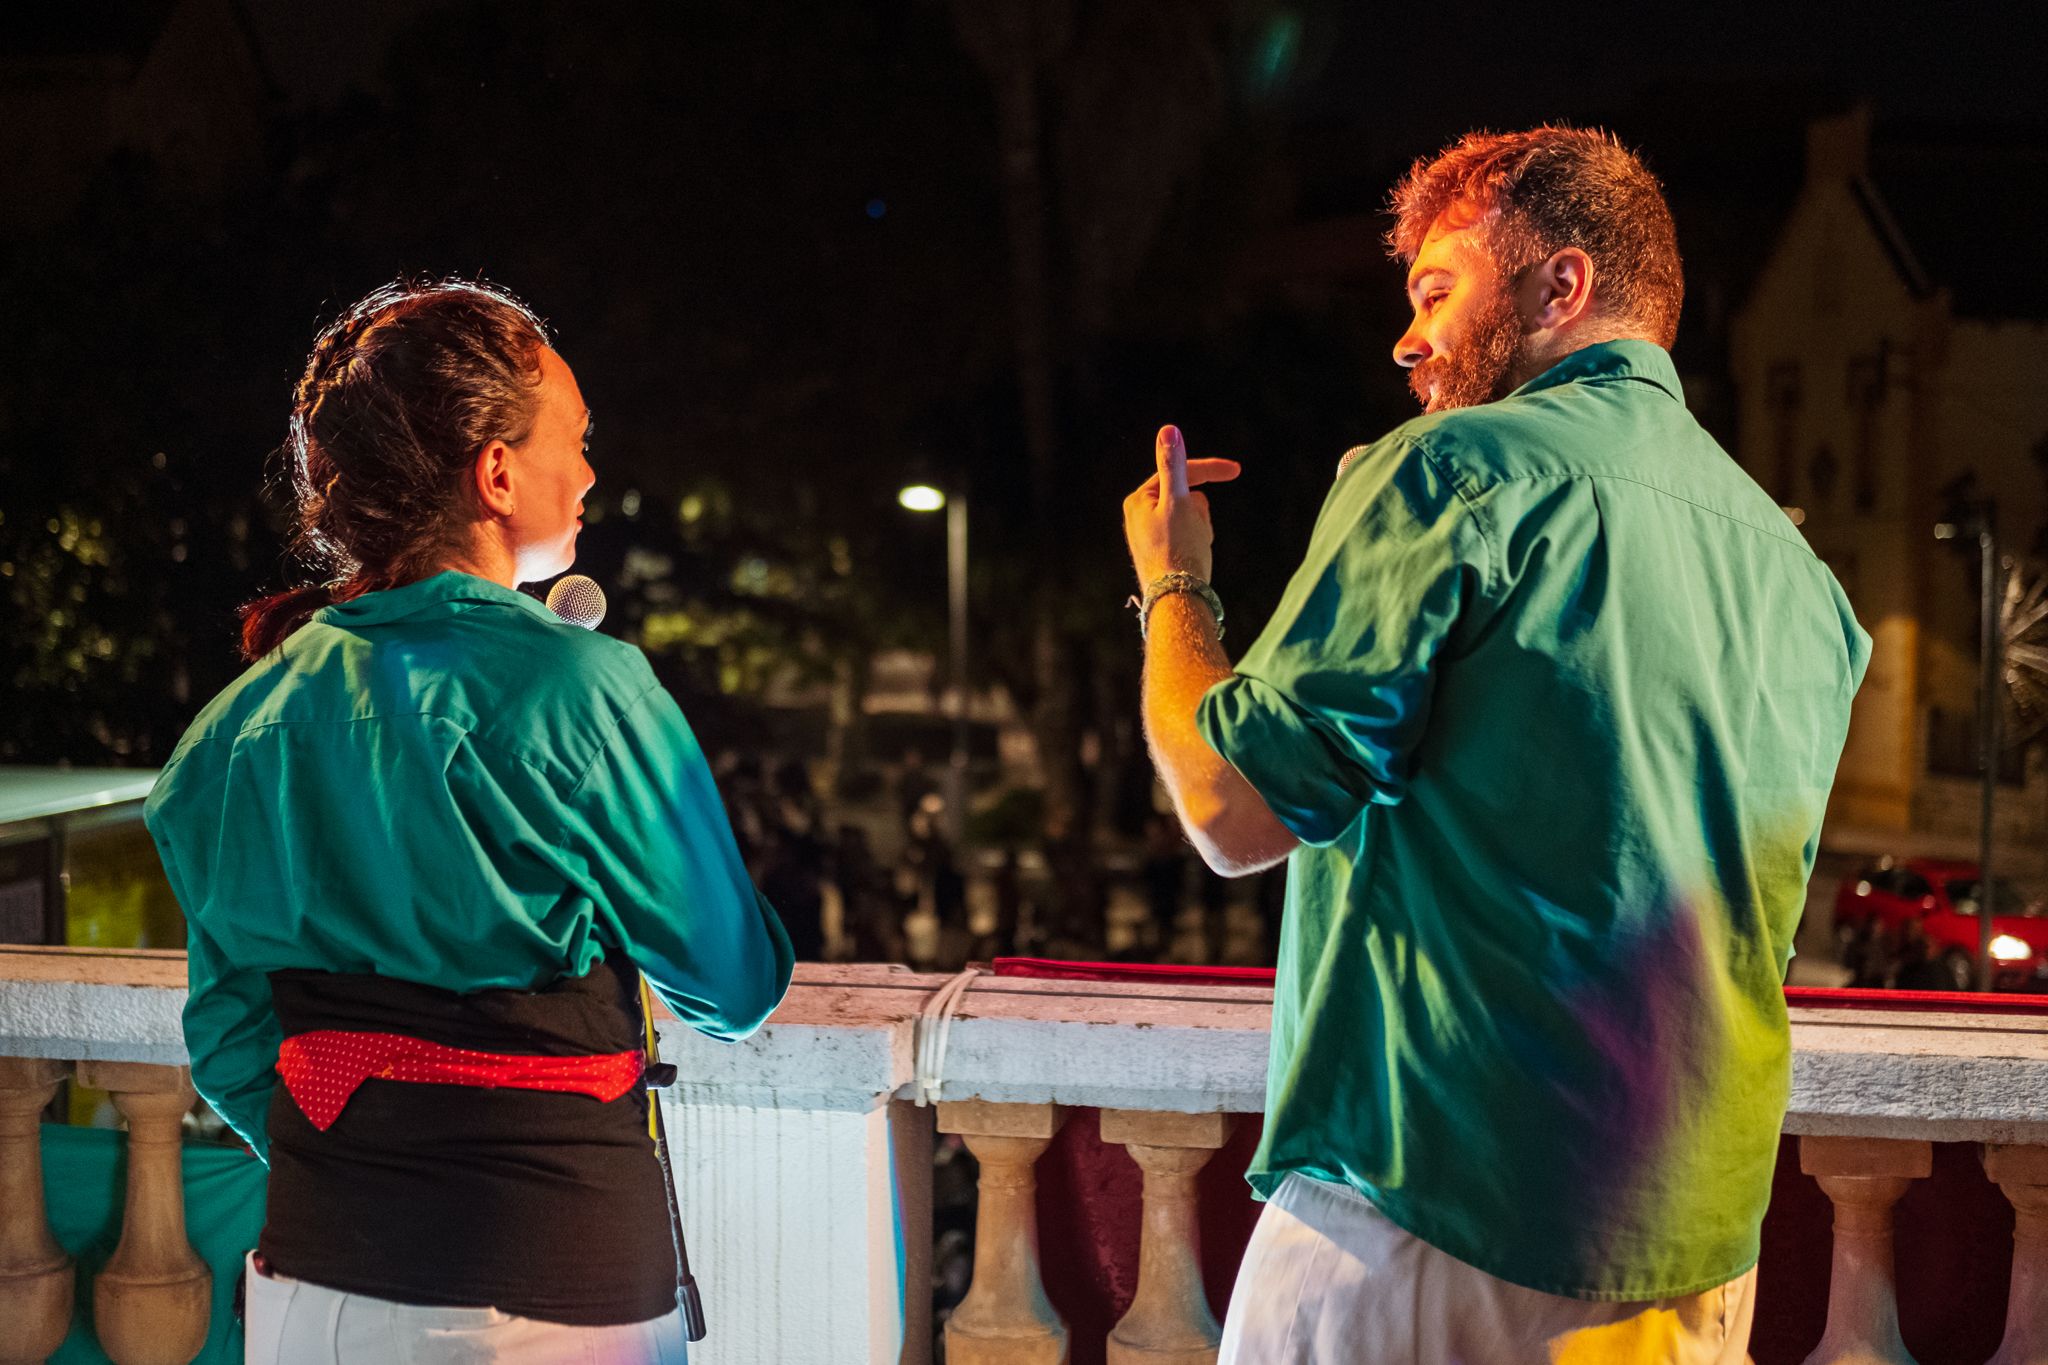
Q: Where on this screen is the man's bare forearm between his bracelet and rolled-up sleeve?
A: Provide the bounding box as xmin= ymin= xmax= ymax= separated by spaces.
xmin=1145 ymin=593 xmax=1296 ymax=876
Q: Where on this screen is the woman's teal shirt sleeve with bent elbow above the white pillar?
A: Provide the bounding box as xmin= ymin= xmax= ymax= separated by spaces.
xmin=567 ymin=686 xmax=795 ymax=1040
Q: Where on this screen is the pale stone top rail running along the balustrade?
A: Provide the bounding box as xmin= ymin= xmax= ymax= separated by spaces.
xmin=12 ymin=948 xmax=2048 ymax=1142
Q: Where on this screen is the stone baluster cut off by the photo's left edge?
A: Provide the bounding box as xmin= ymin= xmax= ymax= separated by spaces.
xmin=0 ymin=1056 xmax=72 ymax=1365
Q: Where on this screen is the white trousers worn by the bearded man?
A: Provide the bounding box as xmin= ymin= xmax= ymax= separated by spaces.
xmin=1217 ymin=1175 xmax=1757 ymax=1365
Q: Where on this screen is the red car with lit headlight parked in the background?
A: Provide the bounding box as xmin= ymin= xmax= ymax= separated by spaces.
xmin=1835 ymin=857 xmax=2048 ymax=990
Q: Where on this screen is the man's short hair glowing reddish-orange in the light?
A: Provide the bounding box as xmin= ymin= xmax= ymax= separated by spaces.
xmin=1386 ymin=125 xmax=1686 ymax=350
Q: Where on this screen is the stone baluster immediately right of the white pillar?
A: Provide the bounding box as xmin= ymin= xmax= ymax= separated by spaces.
xmin=938 ymin=1099 xmax=1067 ymax=1365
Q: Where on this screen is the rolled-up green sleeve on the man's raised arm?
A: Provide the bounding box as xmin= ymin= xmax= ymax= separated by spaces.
xmin=1196 ymin=436 xmax=1487 ymax=845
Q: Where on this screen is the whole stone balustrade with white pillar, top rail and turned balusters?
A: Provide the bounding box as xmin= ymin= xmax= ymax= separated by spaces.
xmin=12 ymin=950 xmax=2048 ymax=1365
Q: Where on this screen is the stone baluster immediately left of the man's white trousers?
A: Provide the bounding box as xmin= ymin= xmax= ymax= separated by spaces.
xmin=1102 ymin=1109 xmax=1231 ymax=1365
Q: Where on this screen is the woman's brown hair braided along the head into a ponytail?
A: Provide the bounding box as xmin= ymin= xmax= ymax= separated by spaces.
xmin=242 ymin=278 xmax=549 ymax=661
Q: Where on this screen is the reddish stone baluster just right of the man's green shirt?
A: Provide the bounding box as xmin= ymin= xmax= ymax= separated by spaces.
xmin=1798 ymin=1138 xmax=1933 ymax=1365
